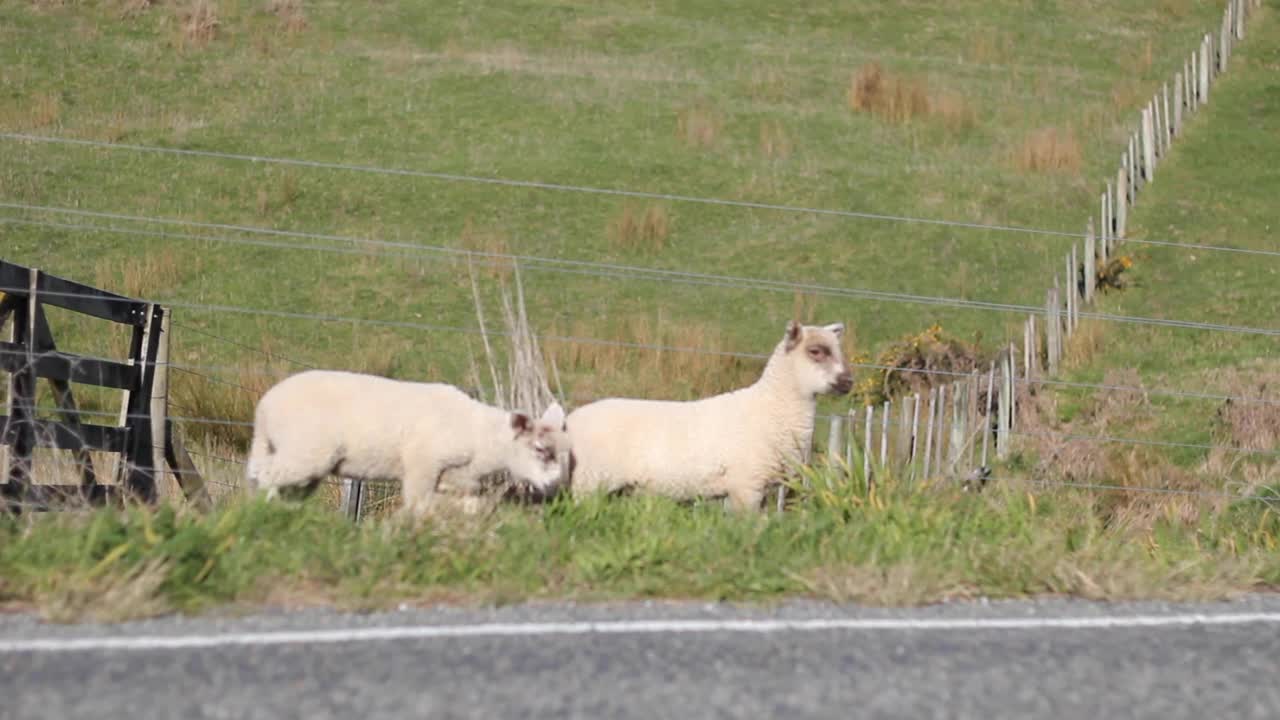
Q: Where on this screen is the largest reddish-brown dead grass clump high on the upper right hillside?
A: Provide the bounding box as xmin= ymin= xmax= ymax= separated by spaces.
xmin=847 ymin=61 xmax=977 ymax=129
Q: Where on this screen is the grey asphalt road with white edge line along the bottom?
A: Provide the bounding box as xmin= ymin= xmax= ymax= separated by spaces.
xmin=0 ymin=596 xmax=1280 ymax=720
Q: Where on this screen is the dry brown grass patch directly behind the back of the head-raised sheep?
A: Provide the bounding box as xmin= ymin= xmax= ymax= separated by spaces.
xmin=544 ymin=314 xmax=764 ymax=405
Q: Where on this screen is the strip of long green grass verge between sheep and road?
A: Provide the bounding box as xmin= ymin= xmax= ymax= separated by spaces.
xmin=0 ymin=469 xmax=1280 ymax=620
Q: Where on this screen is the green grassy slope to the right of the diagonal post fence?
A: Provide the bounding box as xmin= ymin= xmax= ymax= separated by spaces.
xmin=1039 ymin=3 xmax=1280 ymax=479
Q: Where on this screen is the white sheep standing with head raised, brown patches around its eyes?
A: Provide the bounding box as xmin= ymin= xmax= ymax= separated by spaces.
xmin=567 ymin=322 xmax=852 ymax=510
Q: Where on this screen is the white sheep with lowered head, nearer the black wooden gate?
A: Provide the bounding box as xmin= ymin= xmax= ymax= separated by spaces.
xmin=246 ymin=370 xmax=570 ymax=515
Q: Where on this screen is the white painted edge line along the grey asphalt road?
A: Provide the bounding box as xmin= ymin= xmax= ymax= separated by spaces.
xmin=0 ymin=612 xmax=1280 ymax=653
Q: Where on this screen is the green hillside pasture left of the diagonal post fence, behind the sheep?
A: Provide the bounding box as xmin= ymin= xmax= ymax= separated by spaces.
xmin=0 ymin=0 xmax=1219 ymax=400
